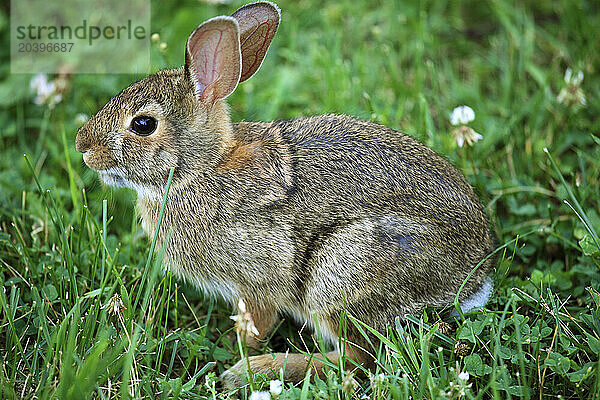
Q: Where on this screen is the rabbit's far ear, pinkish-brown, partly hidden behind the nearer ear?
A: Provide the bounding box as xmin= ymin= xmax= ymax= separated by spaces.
xmin=232 ymin=1 xmax=281 ymax=82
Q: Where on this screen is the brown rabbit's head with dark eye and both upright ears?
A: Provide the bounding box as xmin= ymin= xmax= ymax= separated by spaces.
xmin=76 ymin=2 xmax=280 ymax=195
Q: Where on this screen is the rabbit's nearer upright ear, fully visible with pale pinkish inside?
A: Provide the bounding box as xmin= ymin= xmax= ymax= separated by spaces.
xmin=185 ymin=17 xmax=241 ymax=106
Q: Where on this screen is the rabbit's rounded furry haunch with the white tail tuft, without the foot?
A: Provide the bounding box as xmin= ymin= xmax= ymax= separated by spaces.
xmin=304 ymin=215 xmax=492 ymax=322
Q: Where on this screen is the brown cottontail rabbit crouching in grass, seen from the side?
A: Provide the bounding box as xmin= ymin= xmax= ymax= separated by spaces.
xmin=76 ymin=1 xmax=495 ymax=387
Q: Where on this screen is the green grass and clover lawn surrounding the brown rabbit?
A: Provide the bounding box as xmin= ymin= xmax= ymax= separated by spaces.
xmin=0 ymin=0 xmax=600 ymax=399
